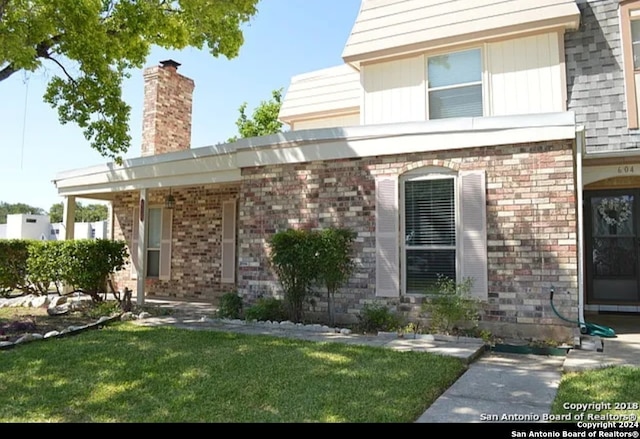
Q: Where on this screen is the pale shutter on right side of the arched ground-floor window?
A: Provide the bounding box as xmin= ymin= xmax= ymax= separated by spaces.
xmin=459 ymin=171 xmax=489 ymax=300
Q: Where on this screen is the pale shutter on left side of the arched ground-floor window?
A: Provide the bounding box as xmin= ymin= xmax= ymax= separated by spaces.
xmin=376 ymin=176 xmax=400 ymax=297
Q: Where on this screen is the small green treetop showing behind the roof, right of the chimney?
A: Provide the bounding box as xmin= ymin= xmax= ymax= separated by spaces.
xmin=228 ymin=89 xmax=282 ymax=142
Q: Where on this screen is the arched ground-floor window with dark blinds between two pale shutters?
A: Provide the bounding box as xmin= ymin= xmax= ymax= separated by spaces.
xmin=404 ymin=177 xmax=456 ymax=294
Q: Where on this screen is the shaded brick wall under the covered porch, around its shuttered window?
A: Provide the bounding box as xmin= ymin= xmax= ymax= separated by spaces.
xmin=113 ymin=184 xmax=238 ymax=302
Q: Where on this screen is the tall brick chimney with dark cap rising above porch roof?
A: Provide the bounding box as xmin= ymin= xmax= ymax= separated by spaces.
xmin=142 ymin=60 xmax=195 ymax=157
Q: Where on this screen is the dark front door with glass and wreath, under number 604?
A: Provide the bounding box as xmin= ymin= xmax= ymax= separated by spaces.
xmin=584 ymin=189 xmax=640 ymax=305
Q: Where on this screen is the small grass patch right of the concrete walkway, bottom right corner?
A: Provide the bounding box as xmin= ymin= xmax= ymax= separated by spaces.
xmin=552 ymin=366 xmax=640 ymax=420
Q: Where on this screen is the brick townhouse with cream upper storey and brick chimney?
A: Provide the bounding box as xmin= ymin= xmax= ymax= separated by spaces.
xmin=55 ymin=0 xmax=640 ymax=336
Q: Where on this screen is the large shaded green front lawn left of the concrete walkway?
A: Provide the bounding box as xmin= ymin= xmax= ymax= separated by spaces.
xmin=0 ymin=323 xmax=464 ymax=423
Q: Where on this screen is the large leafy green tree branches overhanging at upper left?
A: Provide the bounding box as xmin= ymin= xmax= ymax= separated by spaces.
xmin=0 ymin=0 xmax=259 ymax=163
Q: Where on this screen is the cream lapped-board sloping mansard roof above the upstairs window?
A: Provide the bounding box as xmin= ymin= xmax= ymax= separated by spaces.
xmin=342 ymin=0 xmax=580 ymax=67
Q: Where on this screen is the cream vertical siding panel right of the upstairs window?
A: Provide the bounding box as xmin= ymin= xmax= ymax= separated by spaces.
xmin=486 ymin=32 xmax=566 ymax=116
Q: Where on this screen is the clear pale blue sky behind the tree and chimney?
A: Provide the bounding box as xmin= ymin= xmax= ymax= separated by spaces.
xmin=0 ymin=0 xmax=360 ymax=211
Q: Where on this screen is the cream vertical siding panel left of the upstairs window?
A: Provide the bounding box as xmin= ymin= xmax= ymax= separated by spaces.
xmin=361 ymin=55 xmax=426 ymax=125
